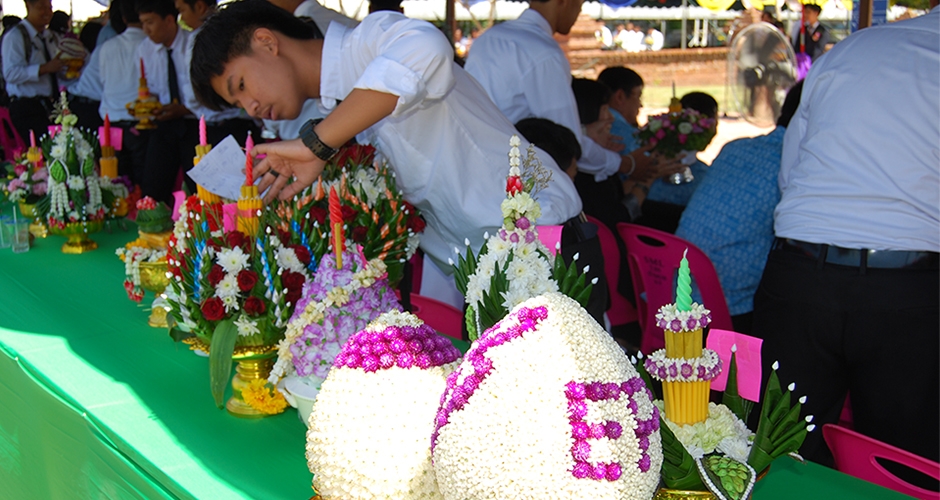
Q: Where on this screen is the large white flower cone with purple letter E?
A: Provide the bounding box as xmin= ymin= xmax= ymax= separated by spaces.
xmin=432 ymin=293 xmax=662 ymax=500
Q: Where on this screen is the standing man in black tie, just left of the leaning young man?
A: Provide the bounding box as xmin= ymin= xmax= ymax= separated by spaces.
xmin=137 ymin=0 xmax=195 ymax=203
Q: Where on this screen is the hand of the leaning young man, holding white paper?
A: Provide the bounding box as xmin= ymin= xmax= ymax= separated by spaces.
xmin=252 ymin=139 xmax=326 ymax=203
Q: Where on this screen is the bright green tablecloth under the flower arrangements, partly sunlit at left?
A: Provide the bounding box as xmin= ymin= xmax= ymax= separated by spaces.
xmin=0 ymin=221 xmax=901 ymax=500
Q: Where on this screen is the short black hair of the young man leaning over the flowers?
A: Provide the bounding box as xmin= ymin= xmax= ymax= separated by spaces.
xmin=190 ymin=0 xmax=318 ymax=111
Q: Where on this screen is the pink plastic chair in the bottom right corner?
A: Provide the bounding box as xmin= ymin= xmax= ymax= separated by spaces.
xmin=823 ymin=424 xmax=940 ymax=500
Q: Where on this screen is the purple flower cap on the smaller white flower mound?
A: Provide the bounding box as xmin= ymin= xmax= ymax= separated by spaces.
xmin=333 ymin=325 xmax=460 ymax=373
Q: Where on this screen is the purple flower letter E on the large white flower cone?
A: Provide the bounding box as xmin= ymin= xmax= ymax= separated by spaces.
xmin=565 ymin=377 xmax=659 ymax=481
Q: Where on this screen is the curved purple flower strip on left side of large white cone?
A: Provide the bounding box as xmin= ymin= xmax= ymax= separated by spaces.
xmin=431 ymin=306 xmax=548 ymax=451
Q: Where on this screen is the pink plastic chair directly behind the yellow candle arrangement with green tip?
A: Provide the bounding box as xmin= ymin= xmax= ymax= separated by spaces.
xmin=617 ymin=223 xmax=734 ymax=353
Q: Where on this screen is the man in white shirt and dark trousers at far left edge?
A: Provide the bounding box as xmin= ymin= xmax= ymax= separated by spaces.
xmin=2 ymin=0 xmax=65 ymax=145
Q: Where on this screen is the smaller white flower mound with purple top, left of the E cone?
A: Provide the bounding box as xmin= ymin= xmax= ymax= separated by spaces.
xmin=306 ymin=311 xmax=459 ymax=500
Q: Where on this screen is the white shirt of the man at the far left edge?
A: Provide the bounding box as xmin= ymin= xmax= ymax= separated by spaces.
xmin=0 ymin=19 xmax=64 ymax=97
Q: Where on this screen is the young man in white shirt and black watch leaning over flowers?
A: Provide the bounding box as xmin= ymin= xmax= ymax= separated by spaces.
xmin=186 ymin=1 xmax=593 ymax=312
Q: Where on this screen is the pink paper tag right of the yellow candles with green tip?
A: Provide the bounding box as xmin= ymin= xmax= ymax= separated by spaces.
xmin=705 ymin=328 xmax=764 ymax=402
